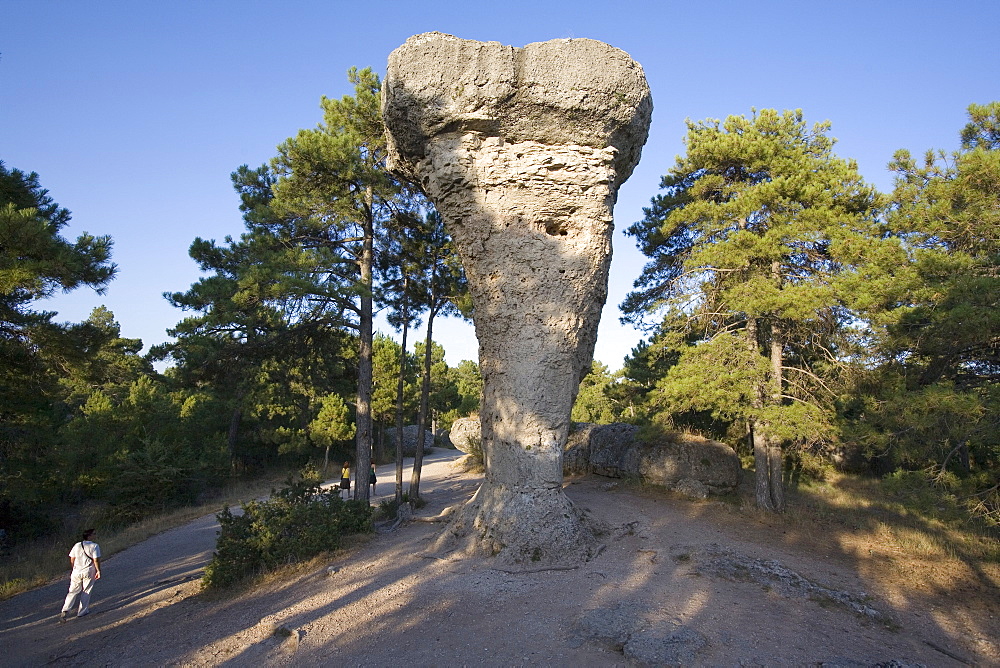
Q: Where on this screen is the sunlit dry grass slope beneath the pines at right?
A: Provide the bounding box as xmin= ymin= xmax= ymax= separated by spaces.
xmin=692 ymin=472 xmax=1000 ymax=614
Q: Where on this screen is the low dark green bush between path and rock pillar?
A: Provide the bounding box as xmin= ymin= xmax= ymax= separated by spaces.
xmin=202 ymin=472 xmax=372 ymax=589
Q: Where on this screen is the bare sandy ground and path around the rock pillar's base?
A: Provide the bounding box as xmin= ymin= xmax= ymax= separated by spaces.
xmin=0 ymin=450 xmax=1000 ymax=666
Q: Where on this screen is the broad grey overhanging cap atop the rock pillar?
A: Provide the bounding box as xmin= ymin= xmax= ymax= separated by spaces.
xmin=382 ymin=32 xmax=653 ymax=188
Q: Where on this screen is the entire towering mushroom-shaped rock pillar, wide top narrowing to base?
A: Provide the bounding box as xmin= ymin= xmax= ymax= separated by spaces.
xmin=382 ymin=33 xmax=652 ymax=564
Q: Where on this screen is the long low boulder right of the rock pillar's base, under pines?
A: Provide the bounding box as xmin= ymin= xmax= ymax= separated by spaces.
xmin=563 ymin=423 xmax=740 ymax=498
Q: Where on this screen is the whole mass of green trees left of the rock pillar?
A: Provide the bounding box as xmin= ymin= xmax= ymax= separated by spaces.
xmin=0 ymin=70 xmax=468 ymax=552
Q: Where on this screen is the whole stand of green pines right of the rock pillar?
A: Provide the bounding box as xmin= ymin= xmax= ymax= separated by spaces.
xmin=610 ymin=103 xmax=1000 ymax=523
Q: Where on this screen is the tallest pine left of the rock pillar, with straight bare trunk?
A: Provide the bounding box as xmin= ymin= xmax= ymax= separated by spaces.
xmin=272 ymin=69 xmax=422 ymax=499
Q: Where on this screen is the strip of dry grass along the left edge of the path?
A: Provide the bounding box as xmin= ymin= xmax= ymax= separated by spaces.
xmin=0 ymin=473 xmax=287 ymax=601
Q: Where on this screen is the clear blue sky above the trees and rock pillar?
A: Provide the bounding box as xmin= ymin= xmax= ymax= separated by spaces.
xmin=0 ymin=0 xmax=1000 ymax=369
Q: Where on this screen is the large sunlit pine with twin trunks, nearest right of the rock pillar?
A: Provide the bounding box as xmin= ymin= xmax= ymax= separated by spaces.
xmin=622 ymin=109 xmax=893 ymax=511
